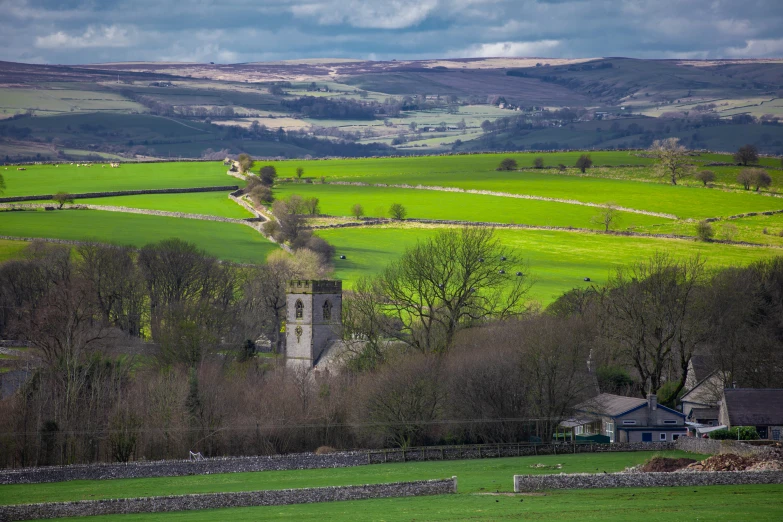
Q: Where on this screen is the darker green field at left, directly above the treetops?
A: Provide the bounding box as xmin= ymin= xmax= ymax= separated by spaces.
xmin=0 ymin=210 xmax=277 ymax=263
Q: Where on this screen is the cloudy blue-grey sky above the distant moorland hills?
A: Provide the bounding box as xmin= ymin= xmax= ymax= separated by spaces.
xmin=0 ymin=0 xmax=783 ymax=64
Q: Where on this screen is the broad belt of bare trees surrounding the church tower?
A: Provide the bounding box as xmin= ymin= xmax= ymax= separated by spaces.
xmin=0 ymin=230 xmax=783 ymax=466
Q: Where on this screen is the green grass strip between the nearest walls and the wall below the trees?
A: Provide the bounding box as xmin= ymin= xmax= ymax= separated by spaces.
xmin=0 ymin=451 xmax=704 ymax=504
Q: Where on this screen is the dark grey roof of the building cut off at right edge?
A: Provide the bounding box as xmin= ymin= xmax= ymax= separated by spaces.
xmin=723 ymin=388 xmax=783 ymax=426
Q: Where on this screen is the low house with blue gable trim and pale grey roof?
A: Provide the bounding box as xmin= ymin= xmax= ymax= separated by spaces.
xmin=563 ymin=393 xmax=687 ymax=442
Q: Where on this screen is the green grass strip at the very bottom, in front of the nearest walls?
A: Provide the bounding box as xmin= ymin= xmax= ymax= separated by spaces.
xmin=53 ymin=485 xmax=783 ymax=522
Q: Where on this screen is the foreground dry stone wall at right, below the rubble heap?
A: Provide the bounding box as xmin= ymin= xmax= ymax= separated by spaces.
xmin=514 ymin=471 xmax=783 ymax=493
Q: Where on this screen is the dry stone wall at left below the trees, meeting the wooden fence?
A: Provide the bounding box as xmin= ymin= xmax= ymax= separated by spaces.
xmin=0 ymin=452 xmax=368 ymax=484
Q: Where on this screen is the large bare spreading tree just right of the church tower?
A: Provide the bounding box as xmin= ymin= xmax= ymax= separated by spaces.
xmin=374 ymin=227 xmax=531 ymax=352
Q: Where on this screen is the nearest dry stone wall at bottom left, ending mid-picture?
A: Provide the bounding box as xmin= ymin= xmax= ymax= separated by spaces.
xmin=0 ymin=477 xmax=457 ymax=521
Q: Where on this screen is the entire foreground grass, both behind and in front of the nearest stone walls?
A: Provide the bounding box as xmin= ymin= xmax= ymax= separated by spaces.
xmin=0 ymin=452 xmax=783 ymax=522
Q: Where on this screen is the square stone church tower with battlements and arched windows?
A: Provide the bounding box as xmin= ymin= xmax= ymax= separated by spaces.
xmin=285 ymin=280 xmax=343 ymax=368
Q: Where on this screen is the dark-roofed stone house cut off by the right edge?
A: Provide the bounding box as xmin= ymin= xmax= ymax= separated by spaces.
xmin=718 ymin=388 xmax=783 ymax=440
